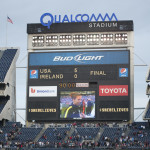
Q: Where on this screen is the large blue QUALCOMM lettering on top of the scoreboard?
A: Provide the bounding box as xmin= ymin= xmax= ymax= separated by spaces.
xmin=40 ymin=13 xmax=118 ymax=29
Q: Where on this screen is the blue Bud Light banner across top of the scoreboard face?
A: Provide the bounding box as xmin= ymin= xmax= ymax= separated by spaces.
xmin=29 ymin=51 xmax=129 ymax=66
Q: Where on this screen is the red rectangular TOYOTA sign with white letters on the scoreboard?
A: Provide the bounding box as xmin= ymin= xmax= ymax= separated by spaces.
xmin=99 ymin=85 xmax=128 ymax=96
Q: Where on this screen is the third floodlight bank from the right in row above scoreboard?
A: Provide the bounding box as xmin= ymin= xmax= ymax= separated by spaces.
xmin=87 ymin=34 xmax=99 ymax=45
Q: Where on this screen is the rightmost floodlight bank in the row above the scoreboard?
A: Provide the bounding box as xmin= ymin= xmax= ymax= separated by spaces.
xmin=115 ymin=33 xmax=128 ymax=44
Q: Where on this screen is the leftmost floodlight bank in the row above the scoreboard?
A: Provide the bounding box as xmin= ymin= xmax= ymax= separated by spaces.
xmin=32 ymin=36 xmax=44 ymax=47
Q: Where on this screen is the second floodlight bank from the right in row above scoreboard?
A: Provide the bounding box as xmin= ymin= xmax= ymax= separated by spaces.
xmin=101 ymin=34 xmax=113 ymax=45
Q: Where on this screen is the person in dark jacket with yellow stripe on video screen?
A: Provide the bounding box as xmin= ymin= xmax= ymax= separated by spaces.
xmin=64 ymin=92 xmax=85 ymax=118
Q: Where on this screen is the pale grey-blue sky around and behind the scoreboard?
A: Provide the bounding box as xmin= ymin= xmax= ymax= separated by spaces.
xmin=0 ymin=0 xmax=150 ymax=123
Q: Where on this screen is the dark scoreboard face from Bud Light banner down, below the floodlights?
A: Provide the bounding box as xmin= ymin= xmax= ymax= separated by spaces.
xmin=27 ymin=50 xmax=130 ymax=121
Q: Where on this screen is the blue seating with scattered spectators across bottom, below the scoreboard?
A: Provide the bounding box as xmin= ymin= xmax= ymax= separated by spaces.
xmin=0 ymin=122 xmax=150 ymax=150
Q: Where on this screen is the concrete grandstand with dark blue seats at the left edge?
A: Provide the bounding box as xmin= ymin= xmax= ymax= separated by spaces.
xmin=0 ymin=48 xmax=19 ymax=121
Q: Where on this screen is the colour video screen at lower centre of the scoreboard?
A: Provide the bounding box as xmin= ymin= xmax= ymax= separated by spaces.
xmin=60 ymin=91 xmax=95 ymax=119
